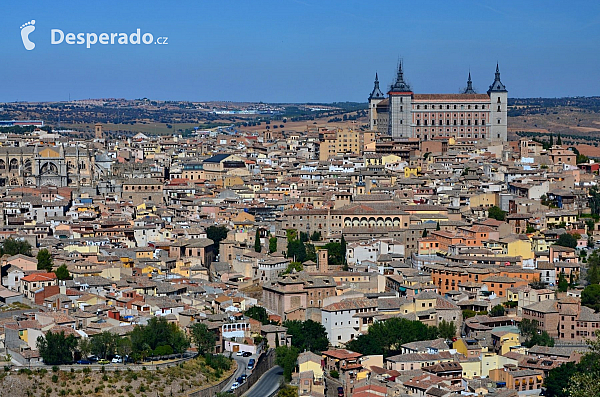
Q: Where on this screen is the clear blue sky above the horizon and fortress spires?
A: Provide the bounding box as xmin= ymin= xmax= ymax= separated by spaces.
xmin=0 ymin=0 xmax=600 ymax=102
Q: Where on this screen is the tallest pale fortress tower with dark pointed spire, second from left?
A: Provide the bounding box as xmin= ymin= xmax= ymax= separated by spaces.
xmin=388 ymin=62 xmax=413 ymax=139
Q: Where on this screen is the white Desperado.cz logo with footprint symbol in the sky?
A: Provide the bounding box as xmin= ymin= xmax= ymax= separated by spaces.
xmin=21 ymin=19 xmax=169 ymax=51
